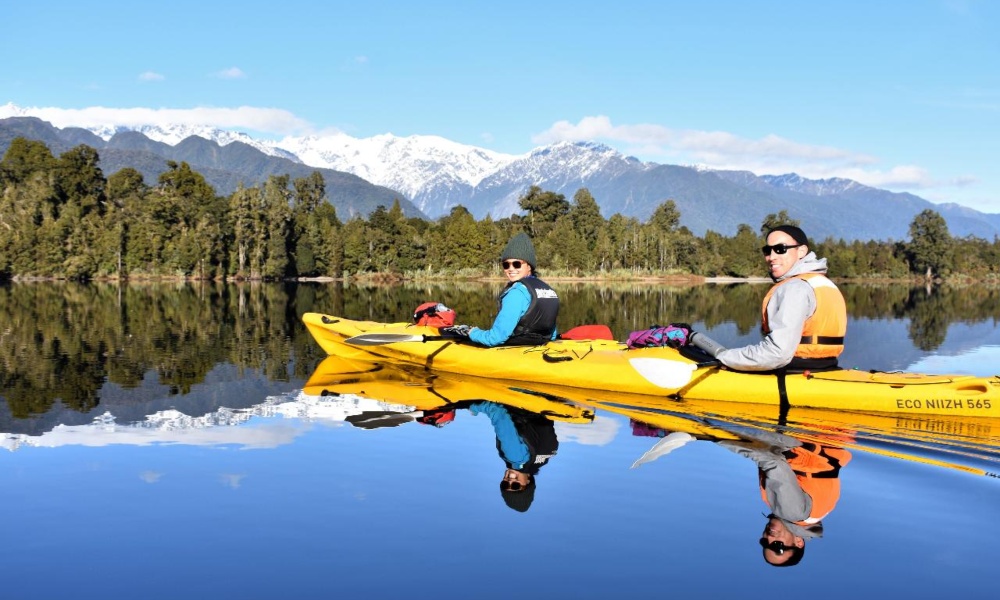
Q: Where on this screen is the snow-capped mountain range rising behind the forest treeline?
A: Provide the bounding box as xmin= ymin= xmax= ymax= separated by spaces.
xmin=0 ymin=105 xmax=1000 ymax=241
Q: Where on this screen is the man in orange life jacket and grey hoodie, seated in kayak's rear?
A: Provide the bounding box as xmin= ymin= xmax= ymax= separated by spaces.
xmin=712 ymin=225 xmax=847 ymax=371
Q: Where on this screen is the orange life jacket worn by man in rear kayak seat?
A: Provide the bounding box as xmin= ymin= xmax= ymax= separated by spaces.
xmin=760 ymin=273 xmax=847 ymax=358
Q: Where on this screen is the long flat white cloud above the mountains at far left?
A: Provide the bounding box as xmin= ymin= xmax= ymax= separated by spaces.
xmin=8 ymin=106 xmax=311 ymax=135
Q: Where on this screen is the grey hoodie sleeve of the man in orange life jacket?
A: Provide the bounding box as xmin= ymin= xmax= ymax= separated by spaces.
xmin=716 ymin=279 xmax=816 ymax=371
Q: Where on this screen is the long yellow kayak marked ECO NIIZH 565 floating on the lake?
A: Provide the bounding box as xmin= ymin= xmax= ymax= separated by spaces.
xmin=302 ymin=313 xmax=1000 ymax=417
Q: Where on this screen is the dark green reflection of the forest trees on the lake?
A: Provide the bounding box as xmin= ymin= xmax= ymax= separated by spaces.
xmin=0 ymin=281 xmax=1000 ymax=418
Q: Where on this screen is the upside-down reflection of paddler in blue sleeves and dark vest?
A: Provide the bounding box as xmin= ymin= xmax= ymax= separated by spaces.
xmin=468 ymin=400 xmax=559 ymax=512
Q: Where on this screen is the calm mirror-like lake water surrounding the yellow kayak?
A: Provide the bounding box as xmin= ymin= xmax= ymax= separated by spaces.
xmin=0 ymin=283 xmax=1000 ymax=599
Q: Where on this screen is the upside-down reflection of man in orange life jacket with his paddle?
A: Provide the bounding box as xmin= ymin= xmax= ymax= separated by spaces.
xmin=632 ymin=422 xmax=851 ymax=567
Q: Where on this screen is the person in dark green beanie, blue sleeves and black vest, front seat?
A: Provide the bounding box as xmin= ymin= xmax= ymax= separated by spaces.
xmin=442 ymin=232 xmax=559 ymax=346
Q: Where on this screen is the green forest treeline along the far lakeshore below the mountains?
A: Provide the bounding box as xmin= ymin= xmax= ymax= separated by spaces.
xmin=0 ymin=138 xmax=1000 ymax=280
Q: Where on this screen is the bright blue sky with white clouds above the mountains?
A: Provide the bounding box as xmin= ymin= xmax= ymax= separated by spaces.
xmin=0 ymin=0 xmax=1000 ymax=213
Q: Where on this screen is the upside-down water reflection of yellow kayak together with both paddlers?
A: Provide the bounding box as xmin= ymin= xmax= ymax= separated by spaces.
xmin=304 ymin=355 xmax=1000 ymax=528
